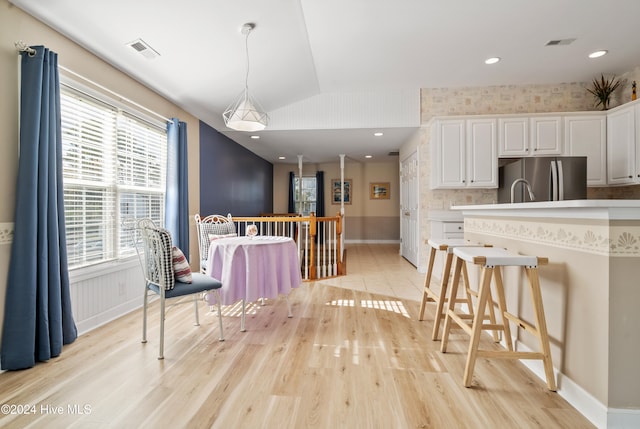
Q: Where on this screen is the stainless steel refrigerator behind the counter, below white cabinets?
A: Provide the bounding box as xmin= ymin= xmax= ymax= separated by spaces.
xmin=498 ymin=156 xmax=587 ymax=203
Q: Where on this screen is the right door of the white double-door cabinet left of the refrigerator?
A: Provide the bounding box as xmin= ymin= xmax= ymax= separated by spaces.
xmin=467 ymin=119 xmax=498 ymax=188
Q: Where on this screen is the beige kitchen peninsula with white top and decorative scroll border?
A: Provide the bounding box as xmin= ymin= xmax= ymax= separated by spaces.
xmin=451 ymin=200 xmax=640 ymax=427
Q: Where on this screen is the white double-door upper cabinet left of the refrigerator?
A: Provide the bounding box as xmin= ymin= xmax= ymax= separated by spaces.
xmin=431 ymin=118 xmax=498 ymax=189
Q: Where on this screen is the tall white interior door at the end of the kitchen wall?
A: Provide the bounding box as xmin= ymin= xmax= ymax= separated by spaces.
xmin=400 ymin=152 xmax=420 ymax=267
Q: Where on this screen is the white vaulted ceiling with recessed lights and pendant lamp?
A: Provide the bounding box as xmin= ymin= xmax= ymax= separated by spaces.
xmin=10 ymin=0 xmax=640 ymax=162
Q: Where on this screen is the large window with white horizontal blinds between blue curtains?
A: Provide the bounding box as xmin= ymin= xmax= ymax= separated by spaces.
xmin=60 ymin=85 xmax=167 ymax=267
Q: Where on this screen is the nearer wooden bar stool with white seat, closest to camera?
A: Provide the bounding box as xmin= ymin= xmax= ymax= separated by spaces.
xmin=440 ymin=247 xmax=557 ymax=391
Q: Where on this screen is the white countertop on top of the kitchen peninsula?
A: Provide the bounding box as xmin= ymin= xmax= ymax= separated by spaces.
xmin=451 ymin=200 xmax=640 ymax=220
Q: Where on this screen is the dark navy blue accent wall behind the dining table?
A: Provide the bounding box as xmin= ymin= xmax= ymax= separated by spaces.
xmin=200 ymin=121 xmax=273 ymax=216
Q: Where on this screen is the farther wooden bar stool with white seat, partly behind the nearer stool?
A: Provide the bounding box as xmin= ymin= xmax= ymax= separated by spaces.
xmin=418 ymin=238 xmax=499 ymax=341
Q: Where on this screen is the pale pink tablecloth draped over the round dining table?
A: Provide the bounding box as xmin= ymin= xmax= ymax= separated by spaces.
xmin=207 ymin=236 xmax=302 ymax=305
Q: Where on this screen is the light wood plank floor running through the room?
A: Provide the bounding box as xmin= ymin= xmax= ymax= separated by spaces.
xmin=0 ymin=245 xmax=593 ymax=429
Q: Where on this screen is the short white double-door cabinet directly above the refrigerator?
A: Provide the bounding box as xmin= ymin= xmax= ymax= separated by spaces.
xmin=498 ymin=115 xmax=563 ymax=158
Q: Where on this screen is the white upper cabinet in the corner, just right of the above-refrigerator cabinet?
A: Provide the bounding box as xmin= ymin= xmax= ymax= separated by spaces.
xmin=564 ymin=113 xmax=607 ymax=186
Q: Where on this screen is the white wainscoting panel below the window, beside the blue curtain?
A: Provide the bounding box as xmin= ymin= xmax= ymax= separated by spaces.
xmin=69 ymin=257 xmax=144 ymax=334
